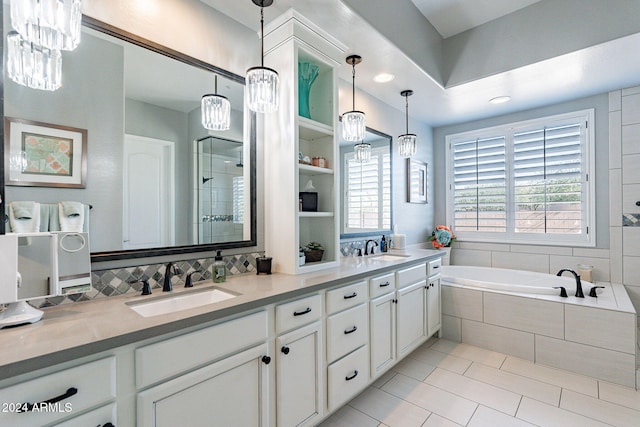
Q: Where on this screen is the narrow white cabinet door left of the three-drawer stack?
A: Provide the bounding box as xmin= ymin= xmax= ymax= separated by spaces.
xmin=276 ymin=322 xmax=324 ymax=426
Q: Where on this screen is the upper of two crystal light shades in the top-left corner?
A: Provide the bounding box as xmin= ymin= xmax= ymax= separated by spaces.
xmin=11 ymin=0 xmax=82 ymax=50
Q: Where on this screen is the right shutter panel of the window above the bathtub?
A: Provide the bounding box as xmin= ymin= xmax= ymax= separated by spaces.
xmin=513 ymin=124 xmax=583 ymax=234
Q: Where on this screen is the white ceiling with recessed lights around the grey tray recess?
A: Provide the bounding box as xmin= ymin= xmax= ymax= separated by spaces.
xmin=205 ymin=0 xmax=640 ymax=127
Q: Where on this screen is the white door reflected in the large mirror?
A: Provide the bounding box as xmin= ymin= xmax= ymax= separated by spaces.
xmin=122 ymin=135 xmax=175 ymax=249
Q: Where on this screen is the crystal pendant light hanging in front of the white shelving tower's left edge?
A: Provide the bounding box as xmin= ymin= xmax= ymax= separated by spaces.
xmin=246 ymin=0 xmax=279 ymax=113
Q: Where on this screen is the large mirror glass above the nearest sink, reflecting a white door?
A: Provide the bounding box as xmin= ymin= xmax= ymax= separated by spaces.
xmin=3 ymin=11 xmax=257 ymax=262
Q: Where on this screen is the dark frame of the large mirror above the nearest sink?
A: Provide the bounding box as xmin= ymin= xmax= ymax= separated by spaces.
xmin=0 ymin=15 xmax=258 ymax=263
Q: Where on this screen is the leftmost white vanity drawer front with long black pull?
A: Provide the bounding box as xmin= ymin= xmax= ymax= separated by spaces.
xmin=0 ymin=356 xmax=117 ymax=426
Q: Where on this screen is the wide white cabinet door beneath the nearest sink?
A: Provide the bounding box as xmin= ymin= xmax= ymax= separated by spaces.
xmin=138 ymin=344 xmax=270 ymax=427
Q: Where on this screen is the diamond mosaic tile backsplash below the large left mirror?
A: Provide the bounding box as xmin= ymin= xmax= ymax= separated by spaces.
xmin=29 ymin=253 xmax=264 ymax=308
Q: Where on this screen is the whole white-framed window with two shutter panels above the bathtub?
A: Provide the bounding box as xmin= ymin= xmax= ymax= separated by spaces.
xmin=446 ymin=110 xmax=595 ymax=246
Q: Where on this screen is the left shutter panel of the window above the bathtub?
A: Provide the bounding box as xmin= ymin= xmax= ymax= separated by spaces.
xmin=451 ymin=136 xmax=507 ymax=233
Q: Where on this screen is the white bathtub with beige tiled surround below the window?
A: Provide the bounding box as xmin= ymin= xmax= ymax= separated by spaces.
xmin=440 ymin=265 xmax=637 ymax=388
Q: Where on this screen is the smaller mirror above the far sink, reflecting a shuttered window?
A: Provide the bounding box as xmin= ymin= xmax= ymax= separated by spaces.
xmin=340 ymin=128 xmax=393 ymax=239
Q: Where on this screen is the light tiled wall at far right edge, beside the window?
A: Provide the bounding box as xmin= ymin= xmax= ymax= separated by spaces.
xmin=609 ymin=87 xmax=640 ymax=319
